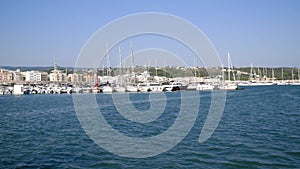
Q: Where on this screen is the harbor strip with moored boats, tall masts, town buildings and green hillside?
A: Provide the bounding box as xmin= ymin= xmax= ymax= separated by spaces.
xmin=0 ymin=50 xmax=300 ymax=95
